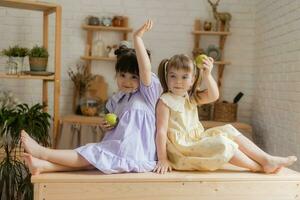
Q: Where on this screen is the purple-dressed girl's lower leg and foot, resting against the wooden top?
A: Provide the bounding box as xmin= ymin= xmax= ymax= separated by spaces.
xmin=23 ymin=153 xmax=94 ymax=175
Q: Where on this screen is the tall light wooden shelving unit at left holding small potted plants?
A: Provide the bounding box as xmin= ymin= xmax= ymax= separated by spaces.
xmin=0 ymin=0 xmax=62 ymax=145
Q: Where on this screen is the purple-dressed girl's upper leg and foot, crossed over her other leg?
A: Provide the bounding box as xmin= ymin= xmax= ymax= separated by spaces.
xmin=21 ymin=131 xmax=91 ymax=168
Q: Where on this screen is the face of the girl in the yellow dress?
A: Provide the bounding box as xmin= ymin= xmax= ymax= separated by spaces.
xmin=167 ymin=67 xmax=195 ymax=96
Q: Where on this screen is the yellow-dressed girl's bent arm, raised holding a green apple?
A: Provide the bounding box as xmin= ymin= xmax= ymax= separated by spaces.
xmin=194 ymin=57 xmax=219 ymax=104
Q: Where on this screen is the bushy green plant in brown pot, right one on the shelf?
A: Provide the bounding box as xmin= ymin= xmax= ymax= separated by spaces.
xmin=28 ymin=45 xmax=49 ymax=72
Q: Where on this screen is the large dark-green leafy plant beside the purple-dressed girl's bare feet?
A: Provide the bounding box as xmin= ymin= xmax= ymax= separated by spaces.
xmin=0 ymin=91 xmax=50 ymax=200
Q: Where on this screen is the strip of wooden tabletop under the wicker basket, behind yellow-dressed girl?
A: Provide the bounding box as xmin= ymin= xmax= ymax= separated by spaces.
xmin=201 ymin=121 xmax=253 ymax=141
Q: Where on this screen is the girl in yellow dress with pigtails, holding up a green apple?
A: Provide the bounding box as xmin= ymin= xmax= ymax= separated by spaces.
xmin=154 ymin=55 xmax=297 ymax=173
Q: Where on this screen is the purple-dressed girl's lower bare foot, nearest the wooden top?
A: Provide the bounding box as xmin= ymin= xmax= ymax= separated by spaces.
xmin=23 ymin=153 xmax=47 ymax=175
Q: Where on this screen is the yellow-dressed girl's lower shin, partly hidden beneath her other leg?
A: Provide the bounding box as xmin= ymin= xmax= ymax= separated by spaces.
xmin=229 ymin=149 xmax=262 ymax=172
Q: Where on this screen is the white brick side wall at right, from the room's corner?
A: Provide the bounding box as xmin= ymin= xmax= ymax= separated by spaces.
xmin=252 ymin=0 xmax=300 ymax=170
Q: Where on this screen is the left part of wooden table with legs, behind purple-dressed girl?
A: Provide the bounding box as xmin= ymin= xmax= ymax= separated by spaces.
xmin=54 ymin=115 xmax=101 ymax=148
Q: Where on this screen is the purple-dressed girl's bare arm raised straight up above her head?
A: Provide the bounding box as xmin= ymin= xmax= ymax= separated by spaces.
xmin=133 ymin=20 xmax=153 ymax=86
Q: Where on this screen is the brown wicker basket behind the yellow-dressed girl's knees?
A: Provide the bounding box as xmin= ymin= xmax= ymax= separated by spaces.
xmin=214 ymin=102 xmax=238 ymax=122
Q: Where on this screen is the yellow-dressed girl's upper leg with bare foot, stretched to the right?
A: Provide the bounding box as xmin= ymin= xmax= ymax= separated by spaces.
xmin=235 ymin=135 xmax=297 ymax=173
